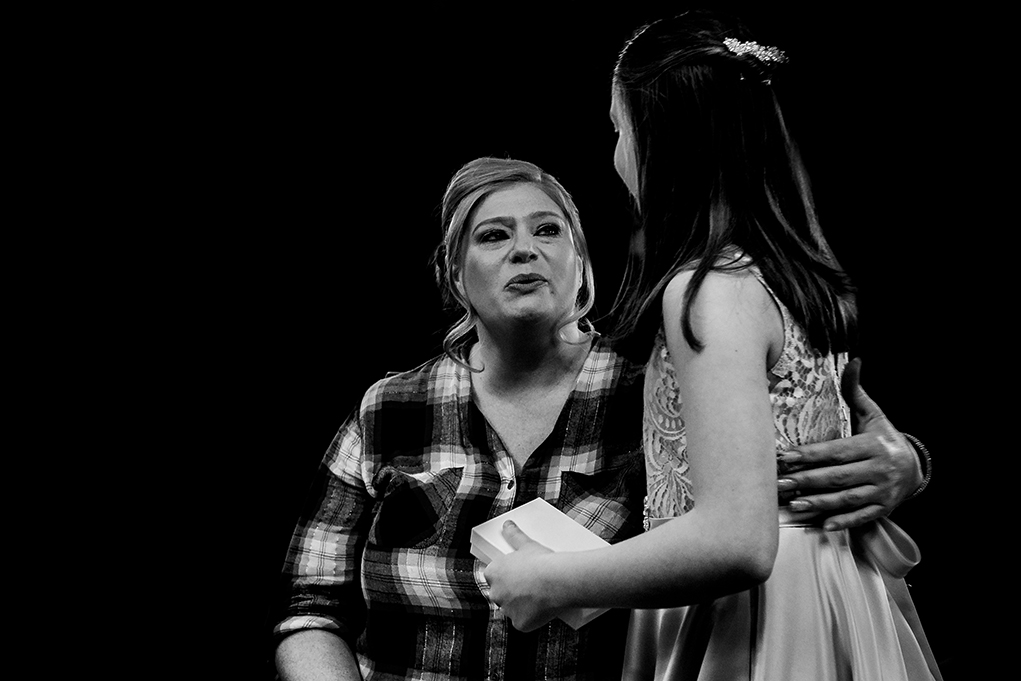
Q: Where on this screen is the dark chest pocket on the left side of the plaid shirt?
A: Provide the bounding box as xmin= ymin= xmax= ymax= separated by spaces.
xmin=369 ymin=466 xmax=464 ymax=549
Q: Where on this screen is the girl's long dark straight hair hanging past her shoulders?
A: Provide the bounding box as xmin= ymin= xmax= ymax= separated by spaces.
xmin=613 ymin=11 xmax=857 ymax=357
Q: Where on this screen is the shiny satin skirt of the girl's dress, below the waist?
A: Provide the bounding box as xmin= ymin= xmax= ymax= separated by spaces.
xmin=624 ymin=514 xmax=942 ymax=681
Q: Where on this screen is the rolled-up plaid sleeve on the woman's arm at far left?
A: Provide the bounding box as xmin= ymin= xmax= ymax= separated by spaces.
xmin=274 ymin=415 xmax=374 ymax=643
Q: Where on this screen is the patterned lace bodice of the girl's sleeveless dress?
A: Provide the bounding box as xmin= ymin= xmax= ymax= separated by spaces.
xmin=643 ymin=266 xmax=850 ymax=518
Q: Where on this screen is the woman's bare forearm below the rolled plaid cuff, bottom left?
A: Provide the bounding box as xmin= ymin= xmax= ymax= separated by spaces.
xmin=276 ymin=629 xmax=361 ymax=681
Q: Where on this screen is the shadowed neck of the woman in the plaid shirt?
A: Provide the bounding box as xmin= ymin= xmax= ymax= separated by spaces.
xmin=471 ymin=324 xmax=591 ymax=392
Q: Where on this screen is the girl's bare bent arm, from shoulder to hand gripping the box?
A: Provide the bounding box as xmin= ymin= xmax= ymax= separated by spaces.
xmin=485 ymin=275 xmax=783 ymax=631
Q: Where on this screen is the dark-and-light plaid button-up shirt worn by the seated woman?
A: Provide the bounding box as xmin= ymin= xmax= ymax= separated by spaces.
xmin=275 ymin=341 xmax=645 ymax=680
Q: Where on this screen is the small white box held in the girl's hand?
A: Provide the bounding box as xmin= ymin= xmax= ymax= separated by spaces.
xmin=472 ymin=499 xmax=610 ymax=629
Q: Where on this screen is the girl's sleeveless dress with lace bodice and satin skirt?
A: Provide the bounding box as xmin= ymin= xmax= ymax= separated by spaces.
xmin=624 ymin=265 xmax=941 ymax=681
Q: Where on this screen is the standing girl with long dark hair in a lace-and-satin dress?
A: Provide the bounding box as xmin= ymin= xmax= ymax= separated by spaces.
xmin=485 ymin=12 xmax=940 ymax=681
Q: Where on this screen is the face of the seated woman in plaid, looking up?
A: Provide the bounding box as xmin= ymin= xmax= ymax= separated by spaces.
xmin=457 ymin=183 xmax=583 ymax=330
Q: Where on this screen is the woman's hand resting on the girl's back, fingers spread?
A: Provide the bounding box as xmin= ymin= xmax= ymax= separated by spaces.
xmin=779 ymin=358 xmax=923 ymax=530
